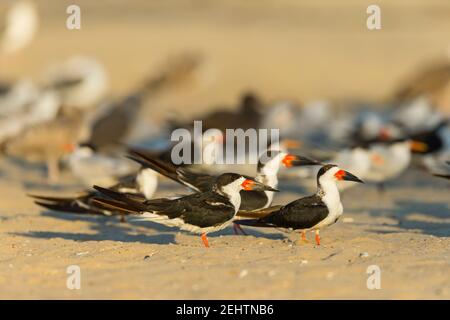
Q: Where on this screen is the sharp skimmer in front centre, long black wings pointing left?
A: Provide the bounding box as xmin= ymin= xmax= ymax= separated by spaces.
xmin=94 ymin=173 xmax=277 ymax=247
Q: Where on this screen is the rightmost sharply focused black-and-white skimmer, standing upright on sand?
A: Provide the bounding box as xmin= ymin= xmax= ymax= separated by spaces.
xmin=236 ymin=164 xmax=363 ymax=245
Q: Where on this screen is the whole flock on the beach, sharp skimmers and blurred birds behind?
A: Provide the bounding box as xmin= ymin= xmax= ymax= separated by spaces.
xmin=0 ymin=1 xmax=450 ymax=247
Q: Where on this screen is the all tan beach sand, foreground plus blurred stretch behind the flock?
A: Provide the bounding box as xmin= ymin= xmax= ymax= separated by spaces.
xmin=0 ymin=0 xmax=450 ymax=299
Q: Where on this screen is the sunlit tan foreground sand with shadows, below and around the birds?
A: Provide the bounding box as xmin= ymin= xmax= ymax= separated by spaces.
xmin=0 ymin=163 xmax=450 ymax=299
